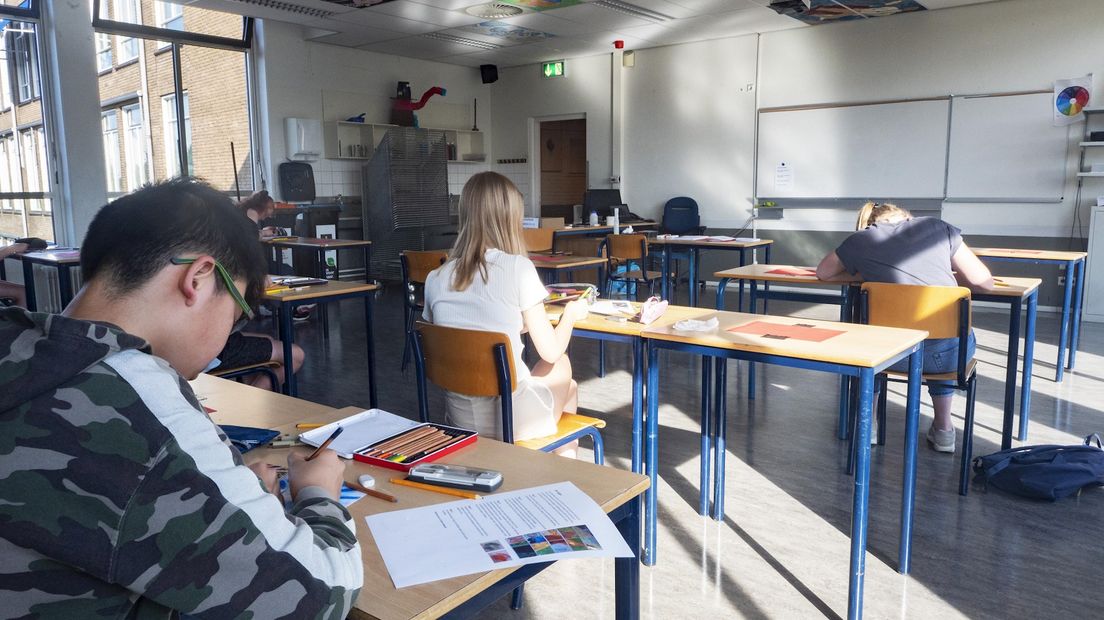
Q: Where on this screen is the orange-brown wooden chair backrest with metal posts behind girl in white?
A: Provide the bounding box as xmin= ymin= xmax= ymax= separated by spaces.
xmin=413 ymin=321 xmax=518 ymax=443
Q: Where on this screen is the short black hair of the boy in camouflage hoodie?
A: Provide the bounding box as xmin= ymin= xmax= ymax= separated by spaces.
xmin=81 ymin=177 xmax=267 ymax=306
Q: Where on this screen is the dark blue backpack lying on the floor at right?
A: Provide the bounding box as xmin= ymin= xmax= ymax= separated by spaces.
xmin=974 ymin=434 xmax=1104 ymax=502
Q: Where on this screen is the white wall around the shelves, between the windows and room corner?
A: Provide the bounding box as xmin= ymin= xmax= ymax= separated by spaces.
xmin=257 ymin=21 xmax=491 ymax=196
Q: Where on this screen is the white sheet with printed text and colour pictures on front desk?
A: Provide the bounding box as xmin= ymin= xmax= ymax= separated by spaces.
xmin=365 ymin=482 xmax=634 ymax=588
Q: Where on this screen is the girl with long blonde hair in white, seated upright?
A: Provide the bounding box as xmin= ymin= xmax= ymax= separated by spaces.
xmin=423 ymin=172 xmax=586 ymax=456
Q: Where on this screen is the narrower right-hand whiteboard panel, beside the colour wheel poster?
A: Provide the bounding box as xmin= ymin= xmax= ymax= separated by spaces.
xmin=947 ymin=93 xmax=1069 ymax=202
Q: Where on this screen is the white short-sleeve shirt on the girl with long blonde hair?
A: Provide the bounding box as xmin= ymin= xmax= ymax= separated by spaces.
xmin=422 ymin=248 xmax=548 ymax=382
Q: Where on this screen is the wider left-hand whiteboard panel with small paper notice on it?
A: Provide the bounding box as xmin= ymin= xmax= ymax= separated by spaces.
xmin=755 ymin=99 xmax=951 ymax=199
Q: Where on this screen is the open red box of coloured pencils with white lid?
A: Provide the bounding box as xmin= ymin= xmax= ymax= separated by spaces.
xmin=299 ymin=409 xmax=478 ymax=471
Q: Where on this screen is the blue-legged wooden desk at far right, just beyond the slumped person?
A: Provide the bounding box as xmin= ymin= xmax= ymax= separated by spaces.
xmin=972 ymin=247 xmax=1089 ymax=381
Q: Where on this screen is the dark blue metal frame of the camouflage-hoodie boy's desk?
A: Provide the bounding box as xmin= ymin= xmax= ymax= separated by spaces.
xmin=442 ymin=495 xmax=640 ymax=620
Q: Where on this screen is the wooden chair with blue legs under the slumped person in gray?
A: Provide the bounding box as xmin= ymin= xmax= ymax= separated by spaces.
xmin=851 ymin=282 xmax=977 ymax=495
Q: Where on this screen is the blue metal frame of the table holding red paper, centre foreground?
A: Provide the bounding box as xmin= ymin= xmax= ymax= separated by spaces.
xmin=644 ymin=334 xmax=924 ymax=618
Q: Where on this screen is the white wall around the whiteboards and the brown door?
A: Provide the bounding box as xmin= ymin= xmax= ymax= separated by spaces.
xmin=492 ymin=0 xmax=1104 ymax=237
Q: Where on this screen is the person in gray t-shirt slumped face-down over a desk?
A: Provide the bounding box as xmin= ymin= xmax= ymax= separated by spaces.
xmin=817 ymin=202 xmax=994 ymax=453
